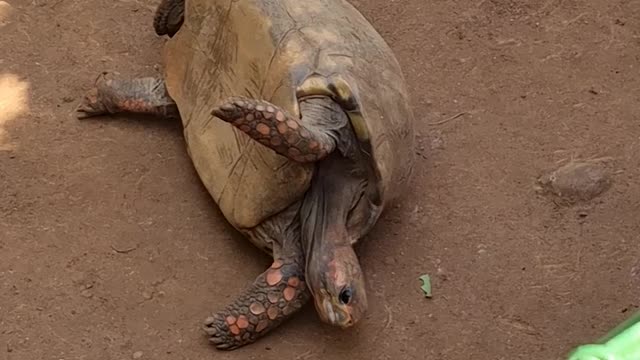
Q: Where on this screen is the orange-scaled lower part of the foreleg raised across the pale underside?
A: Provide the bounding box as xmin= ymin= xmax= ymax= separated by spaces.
xmin=212 ymin=97 xmax=336 ymax=162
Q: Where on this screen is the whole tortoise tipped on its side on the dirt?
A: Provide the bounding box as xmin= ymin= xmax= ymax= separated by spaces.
xmin=77 ymin=0 xmax=414 ymax=350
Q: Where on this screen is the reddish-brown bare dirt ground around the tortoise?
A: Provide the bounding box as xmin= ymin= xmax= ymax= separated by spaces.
xmin=0 ymin=0 xmax=640 ymax=360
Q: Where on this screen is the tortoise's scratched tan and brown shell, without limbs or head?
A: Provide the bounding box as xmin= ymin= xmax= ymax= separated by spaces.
xmin=164 ymin=0 xmax=413 ymax=229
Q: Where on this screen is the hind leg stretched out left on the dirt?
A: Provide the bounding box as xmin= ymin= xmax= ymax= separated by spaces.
xmin=76 ymin=73 xmax=179 ymax=119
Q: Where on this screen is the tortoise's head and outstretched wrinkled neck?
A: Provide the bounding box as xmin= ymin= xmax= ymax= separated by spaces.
xmin=301 ymin=152 xmax=372 ymax=328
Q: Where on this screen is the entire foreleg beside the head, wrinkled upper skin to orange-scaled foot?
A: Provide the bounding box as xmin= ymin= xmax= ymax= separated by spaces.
xmin=204 ymin=205 xmax=311 ymax=350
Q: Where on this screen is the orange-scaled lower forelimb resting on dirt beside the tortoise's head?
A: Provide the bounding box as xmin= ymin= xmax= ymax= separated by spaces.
xmin=204 ymin=260 xmax=311 ymax=350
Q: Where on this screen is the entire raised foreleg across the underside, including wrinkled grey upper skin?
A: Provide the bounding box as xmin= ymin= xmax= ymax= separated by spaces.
xmin=212 ymin=96 xmax=349 ymax=162
